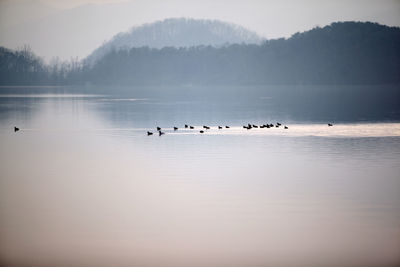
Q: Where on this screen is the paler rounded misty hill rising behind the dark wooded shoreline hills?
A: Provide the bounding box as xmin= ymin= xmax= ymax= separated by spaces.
xmin=86 ymin=18 xmax=263 ymax=64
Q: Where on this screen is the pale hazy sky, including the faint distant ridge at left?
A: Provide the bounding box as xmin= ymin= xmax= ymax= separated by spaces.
xmin=0 ymin=0 xmax=400 ymax=60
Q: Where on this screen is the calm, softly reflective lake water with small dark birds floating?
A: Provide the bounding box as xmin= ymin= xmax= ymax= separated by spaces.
xmin=0 ymin=86 xmax=400 ymax=267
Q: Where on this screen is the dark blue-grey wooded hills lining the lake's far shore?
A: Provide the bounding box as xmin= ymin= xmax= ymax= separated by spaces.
xmin=0 ymin=22 xmax=400 ymax=85
